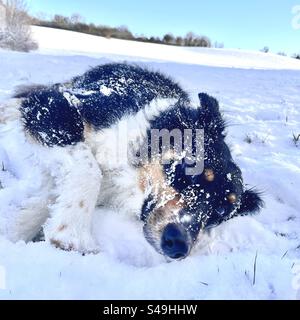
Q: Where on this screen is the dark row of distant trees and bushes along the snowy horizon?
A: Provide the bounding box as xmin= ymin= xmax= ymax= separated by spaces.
xmin=32 ymin=14 xmax=224 ymax=48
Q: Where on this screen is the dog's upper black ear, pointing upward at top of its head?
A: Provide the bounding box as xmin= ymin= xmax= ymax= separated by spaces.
xmin=198 ymin=93 xmax=225 ymax=135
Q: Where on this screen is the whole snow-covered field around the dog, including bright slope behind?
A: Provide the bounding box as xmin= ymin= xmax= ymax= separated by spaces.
xmin=0 ymin=27 xmax=300 ymax=299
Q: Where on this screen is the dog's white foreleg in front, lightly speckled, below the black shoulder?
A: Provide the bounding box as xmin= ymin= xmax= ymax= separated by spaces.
xmin=44 ymin=143 xmax=102 ymax=253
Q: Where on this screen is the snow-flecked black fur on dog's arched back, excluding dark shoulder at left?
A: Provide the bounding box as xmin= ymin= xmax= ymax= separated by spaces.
xmin=72 ymin=64 xmax=188 ymax=129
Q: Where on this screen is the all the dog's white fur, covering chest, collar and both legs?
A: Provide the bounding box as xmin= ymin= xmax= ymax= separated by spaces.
xmin=0 ymin=99 xmax=176 ymax=252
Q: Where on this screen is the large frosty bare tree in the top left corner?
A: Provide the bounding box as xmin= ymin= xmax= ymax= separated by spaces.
xmin=0 ymin=0 xmax=37 ymax=52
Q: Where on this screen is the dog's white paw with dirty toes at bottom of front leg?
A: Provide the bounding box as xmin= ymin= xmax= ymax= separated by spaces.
xmin=48 ymin=231 xmax=100 ymax=254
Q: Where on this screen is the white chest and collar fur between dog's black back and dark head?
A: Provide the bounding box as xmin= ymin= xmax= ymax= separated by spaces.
xmin=85 ymin=99 xmax=176 ymax=216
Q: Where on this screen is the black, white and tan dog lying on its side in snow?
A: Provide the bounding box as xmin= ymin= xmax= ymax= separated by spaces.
xmin=0 ymin=64 xmax=262 ymax=259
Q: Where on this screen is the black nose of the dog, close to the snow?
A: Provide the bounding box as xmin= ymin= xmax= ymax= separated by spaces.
xmin=161 ymin=223 xmax=189 ymax=259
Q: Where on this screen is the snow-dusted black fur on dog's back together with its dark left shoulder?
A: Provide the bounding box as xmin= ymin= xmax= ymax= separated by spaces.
xmin=15 ymin=64 xmax=188 ymax=146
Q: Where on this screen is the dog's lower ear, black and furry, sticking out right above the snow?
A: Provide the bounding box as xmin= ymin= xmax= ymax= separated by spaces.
xmin=237 ymin=189 xmax=264 ymax=215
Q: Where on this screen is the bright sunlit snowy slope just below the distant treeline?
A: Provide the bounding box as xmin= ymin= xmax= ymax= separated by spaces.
xmin=32 ymin=27 xmax=300 ymax=70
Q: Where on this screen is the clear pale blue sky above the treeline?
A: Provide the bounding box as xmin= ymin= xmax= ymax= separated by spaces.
xmin=27 ymin=0 xmax=300 ymax=54
